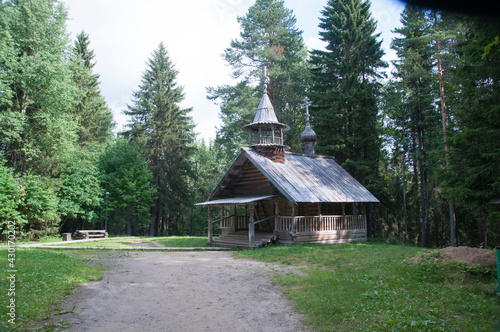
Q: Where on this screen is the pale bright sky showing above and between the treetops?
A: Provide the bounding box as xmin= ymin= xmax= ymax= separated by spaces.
xmin=63 ymin=0 xmax=404 ymax=143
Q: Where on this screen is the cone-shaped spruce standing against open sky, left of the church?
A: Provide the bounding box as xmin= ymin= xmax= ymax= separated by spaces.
xmin=124 ymin=43 xmax=194 ymax=235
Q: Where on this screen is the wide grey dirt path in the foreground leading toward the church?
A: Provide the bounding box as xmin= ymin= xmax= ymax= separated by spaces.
xmin=58 ymin=252 xmax=305 ymax=332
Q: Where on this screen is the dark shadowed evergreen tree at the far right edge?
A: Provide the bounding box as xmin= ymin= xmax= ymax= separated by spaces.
xmin=447 ymin=18 xmax=500 ymax=246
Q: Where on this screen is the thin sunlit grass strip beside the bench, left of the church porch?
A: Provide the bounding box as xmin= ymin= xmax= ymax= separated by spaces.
xmin=55 ymin=236 xmax=208 ymax=249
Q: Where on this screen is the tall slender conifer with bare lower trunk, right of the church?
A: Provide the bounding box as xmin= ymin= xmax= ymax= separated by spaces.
xmin=391 ymin=5 xmax=439 ymax=247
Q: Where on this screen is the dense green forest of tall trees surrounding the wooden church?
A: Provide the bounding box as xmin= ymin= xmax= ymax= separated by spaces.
xmin=0 ymin=0 xmax=500 ymax=247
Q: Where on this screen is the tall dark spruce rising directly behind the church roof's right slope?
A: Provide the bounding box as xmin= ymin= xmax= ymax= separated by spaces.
xmin=310 ymin=0 xmax=387 ymax=198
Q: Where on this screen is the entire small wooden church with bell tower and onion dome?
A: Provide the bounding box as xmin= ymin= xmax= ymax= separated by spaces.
xmin=197 ymin=74 xmax=378 ymax=248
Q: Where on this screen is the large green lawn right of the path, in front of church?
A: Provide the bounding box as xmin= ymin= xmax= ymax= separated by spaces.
xmin=235 ymin=243 xmax=500 ymax=331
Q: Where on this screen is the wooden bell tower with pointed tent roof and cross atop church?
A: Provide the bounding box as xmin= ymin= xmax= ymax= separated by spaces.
xmin=243 ymin=66 xmax=290 ymax=163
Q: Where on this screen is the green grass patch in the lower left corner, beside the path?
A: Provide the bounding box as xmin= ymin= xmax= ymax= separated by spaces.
xmin=0 ymin=248 xmax=103 ymax=331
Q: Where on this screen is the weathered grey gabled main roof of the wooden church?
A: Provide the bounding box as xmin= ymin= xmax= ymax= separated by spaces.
xmin=203 ymin=148 xmax=379 ymax=204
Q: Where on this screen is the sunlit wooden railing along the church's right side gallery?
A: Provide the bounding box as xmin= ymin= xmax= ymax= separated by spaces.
xmin=276 ymin=215 xmax=366 ymax=233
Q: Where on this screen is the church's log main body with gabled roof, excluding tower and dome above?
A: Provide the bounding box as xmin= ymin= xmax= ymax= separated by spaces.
xmin=198 ymin=148 xmax=378 ymax=246
